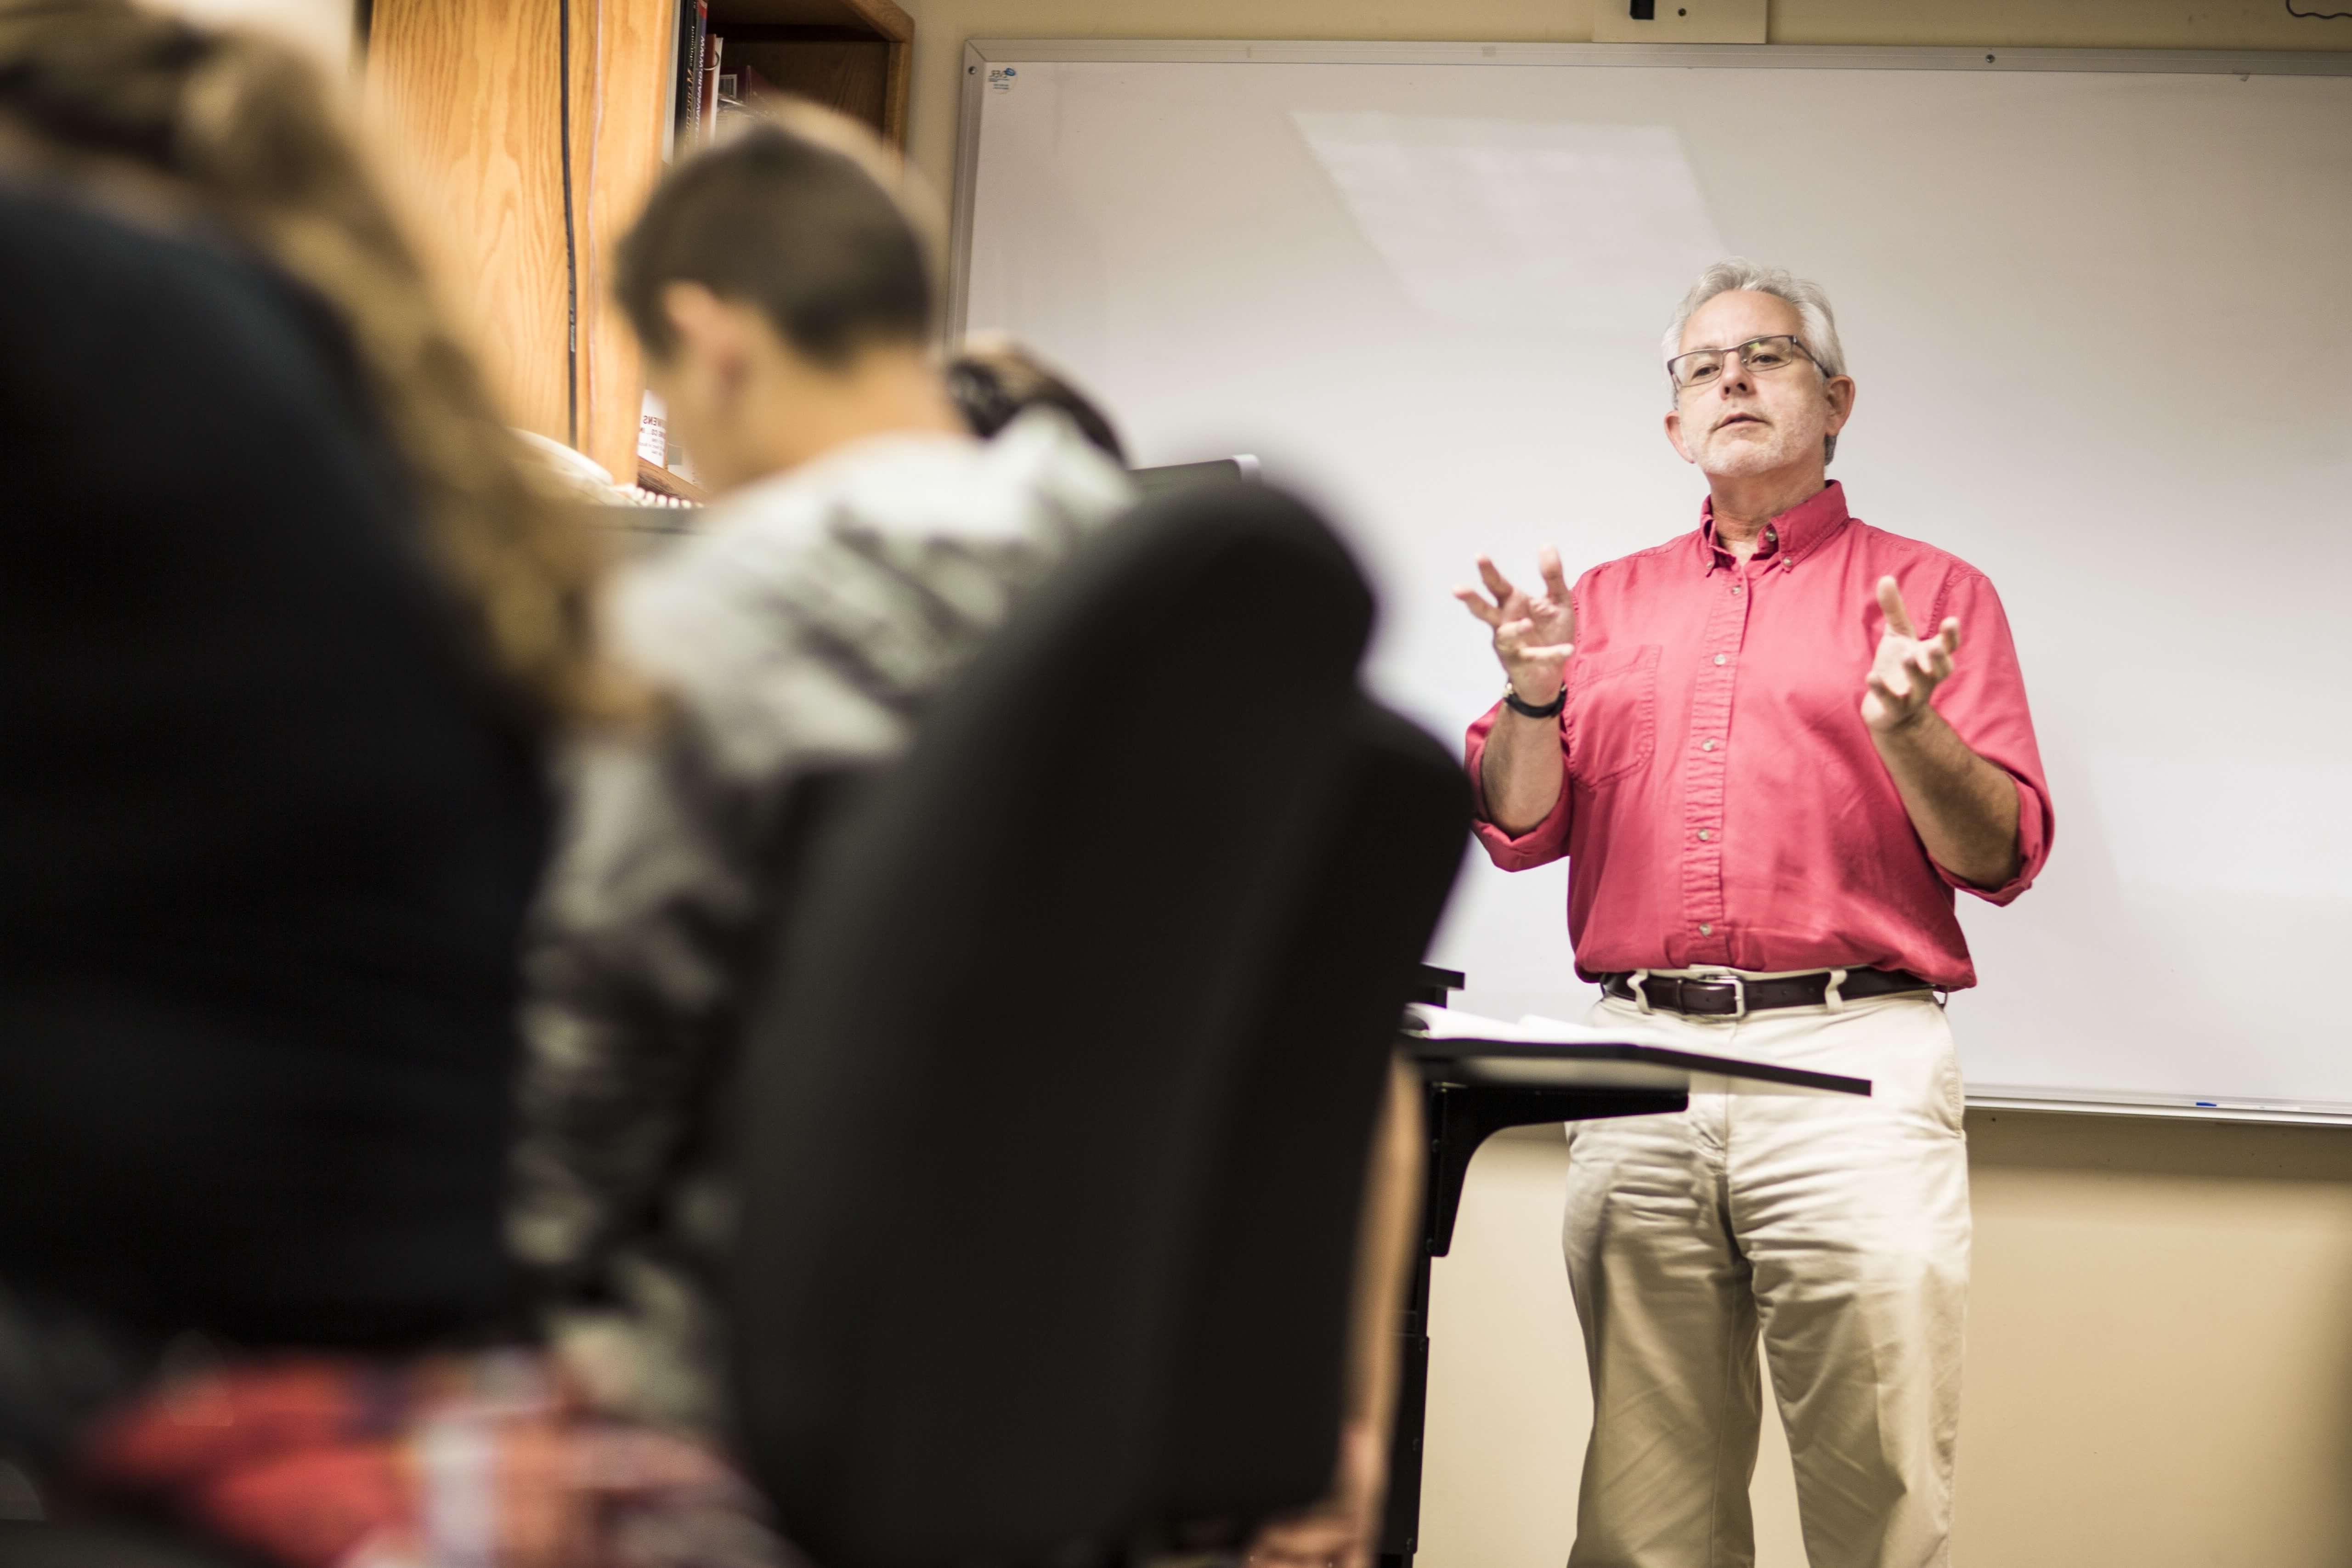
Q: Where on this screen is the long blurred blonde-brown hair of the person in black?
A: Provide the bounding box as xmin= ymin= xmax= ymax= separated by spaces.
xmin=0 ymin=0 xmax=626 ymax=719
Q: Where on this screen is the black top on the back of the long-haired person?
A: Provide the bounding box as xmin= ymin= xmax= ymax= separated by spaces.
xmin=0 ymin=188 xmax=548 ymax=1345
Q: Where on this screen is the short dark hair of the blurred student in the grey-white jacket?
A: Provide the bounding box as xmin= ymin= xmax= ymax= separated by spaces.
xmin=616 ymin=125 xmax=932 ymax=364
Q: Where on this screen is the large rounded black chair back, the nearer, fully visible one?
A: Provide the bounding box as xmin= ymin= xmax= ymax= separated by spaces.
xmin=734 ymin=487 xmax=1371 ymax=1568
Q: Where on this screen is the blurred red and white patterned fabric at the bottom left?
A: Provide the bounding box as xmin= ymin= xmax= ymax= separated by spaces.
xmin=80 ymin=1352 xmax=795 ymax=1568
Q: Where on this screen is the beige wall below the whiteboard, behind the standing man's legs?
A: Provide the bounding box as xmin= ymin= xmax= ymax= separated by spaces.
xmin=1420 ymin=1112 xmax=2352 ymax=1568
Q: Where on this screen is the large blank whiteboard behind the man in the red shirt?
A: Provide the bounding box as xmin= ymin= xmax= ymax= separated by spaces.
xmin=953 ymin=40 xmax=2352 ymax=1119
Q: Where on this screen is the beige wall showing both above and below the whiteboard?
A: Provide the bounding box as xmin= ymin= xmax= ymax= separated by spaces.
xmin=905 ymin=0 xmax=2352 ymax=1568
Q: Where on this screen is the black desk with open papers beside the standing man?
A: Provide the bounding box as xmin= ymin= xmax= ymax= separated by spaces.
xmin=1378 ymin=968 xmax=1870 ymax=1568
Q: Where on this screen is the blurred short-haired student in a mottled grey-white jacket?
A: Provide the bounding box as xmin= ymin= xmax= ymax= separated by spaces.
xmin=510 ymin=110 xmax=1131 ymax=1427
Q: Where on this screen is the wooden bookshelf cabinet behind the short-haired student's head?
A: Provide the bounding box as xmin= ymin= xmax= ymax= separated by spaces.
xmin=362 ymin=0 xmax=915 ymax=494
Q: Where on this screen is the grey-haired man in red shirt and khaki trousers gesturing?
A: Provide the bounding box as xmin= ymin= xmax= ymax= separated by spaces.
xmin=1458 ymin=261 xmax=2051 ymax=1568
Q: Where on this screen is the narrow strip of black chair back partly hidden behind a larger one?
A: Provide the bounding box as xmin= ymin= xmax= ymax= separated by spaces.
xmin=1143 ymin=701 xmax=1470 ymax=1528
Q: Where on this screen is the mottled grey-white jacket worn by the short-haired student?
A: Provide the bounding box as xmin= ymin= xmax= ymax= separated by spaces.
xmin=508 ymin=411 xmax=1134 ymax=1427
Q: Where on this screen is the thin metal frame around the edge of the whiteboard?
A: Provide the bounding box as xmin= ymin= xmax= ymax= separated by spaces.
xmin=945 ymin=38 xmax=2352 ymax=1126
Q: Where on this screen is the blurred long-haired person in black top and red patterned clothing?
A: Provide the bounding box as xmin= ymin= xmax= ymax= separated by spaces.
xmin=0 ymin=0 xmax=783 ymax=1568
